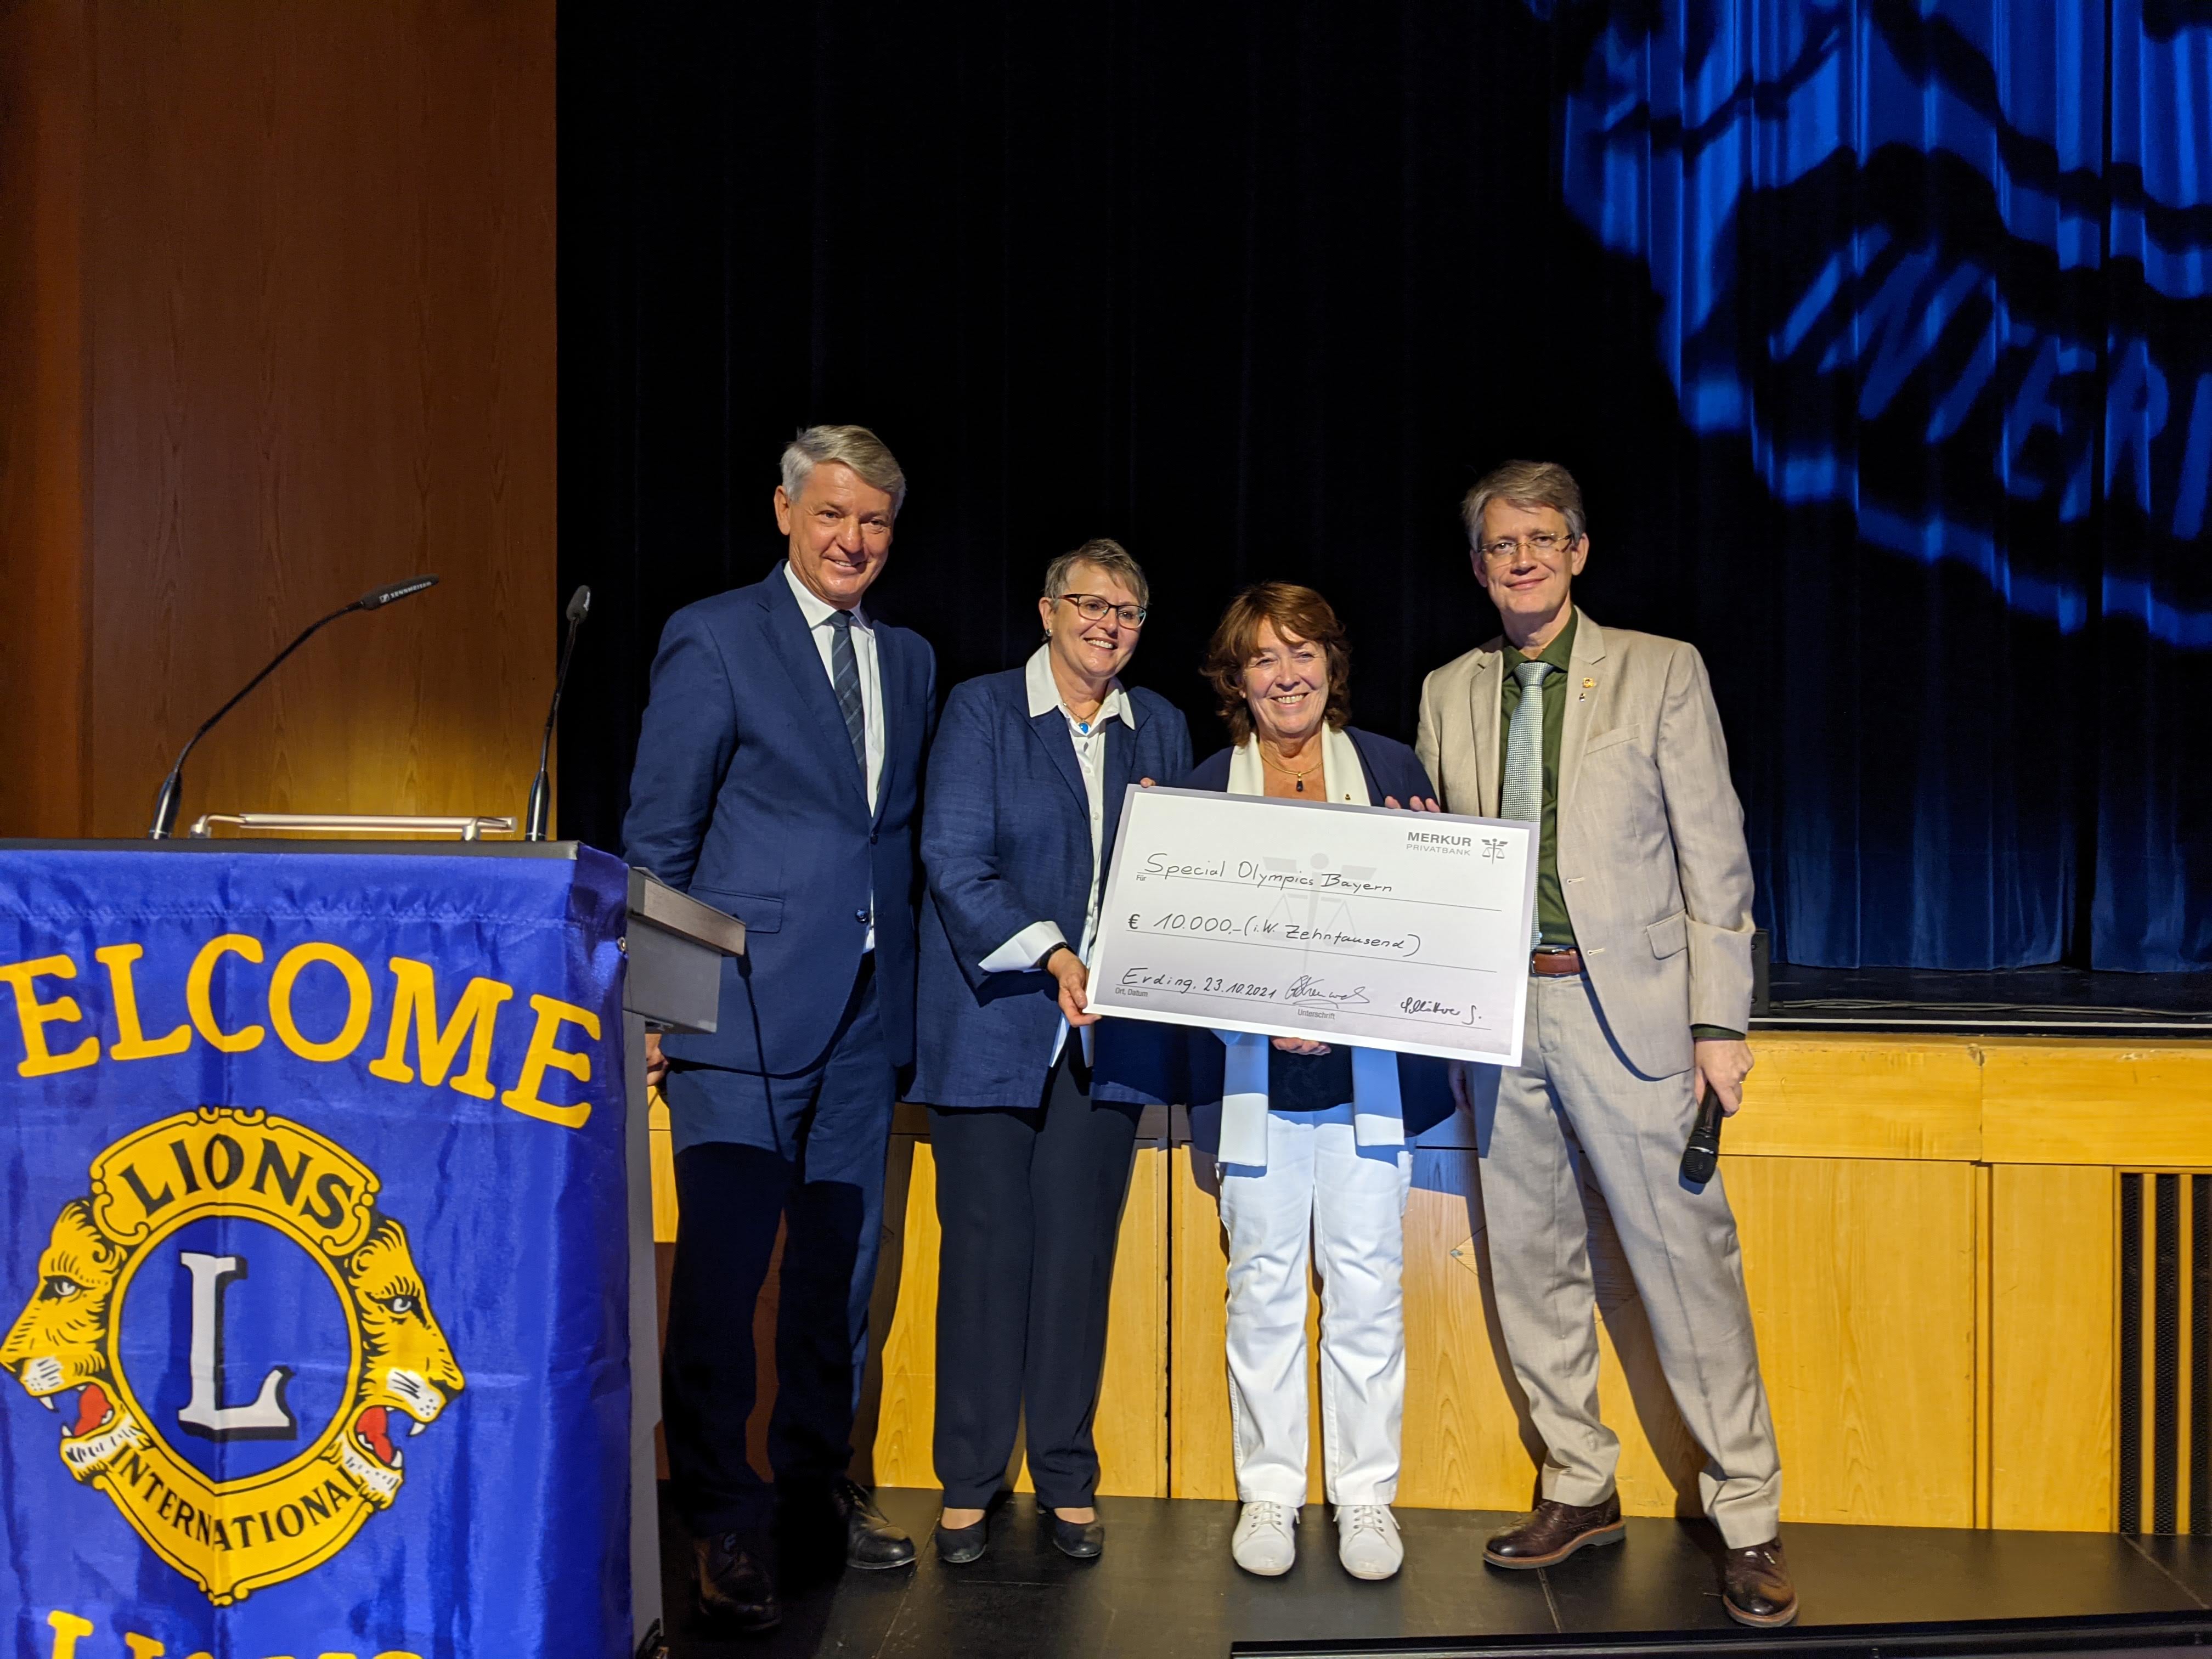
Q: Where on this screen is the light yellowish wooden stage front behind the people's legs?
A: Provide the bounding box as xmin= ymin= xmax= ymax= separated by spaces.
xmin=652 ymin=1033 xmax=2212 ymax=1531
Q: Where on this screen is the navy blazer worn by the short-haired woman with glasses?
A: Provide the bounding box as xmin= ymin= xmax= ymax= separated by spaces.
xmin=911 ymin=668 xmax=1190 ymax=1106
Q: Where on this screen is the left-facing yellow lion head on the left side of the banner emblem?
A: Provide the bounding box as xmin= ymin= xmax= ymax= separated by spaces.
xmin=0 ymin=1199 xmax=142 ymax=1480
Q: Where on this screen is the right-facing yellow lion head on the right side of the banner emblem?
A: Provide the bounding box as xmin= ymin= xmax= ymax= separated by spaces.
xmin=323 ymin=1217 xmax=465 ymax=1509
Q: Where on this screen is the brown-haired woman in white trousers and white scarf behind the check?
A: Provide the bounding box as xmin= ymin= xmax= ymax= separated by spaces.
xmin=1188 ymin=582 xmax=1451 ymax=1579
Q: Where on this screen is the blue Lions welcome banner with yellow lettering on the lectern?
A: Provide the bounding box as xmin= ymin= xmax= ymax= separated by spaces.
xmin=0 ymin=847 xmax=630 ymax=1659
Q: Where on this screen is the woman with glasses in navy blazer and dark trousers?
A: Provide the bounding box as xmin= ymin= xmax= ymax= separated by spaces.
xmin=913 ymin=540 xmax=1190 ymax=1564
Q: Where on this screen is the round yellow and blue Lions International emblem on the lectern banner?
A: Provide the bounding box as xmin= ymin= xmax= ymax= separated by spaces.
xmin=0 ymin=1106 xmax=462 ymax=1606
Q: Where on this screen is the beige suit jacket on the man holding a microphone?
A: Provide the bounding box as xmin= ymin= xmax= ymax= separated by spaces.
xmin=1415 ymin=613 xmax=1752 ymax=1077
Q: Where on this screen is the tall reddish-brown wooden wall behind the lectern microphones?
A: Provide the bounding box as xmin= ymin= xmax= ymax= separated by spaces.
xmin=0 ymin=0 xmax=560 ymax=834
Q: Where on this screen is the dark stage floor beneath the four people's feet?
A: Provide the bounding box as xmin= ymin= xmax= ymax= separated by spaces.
xmin=662 ymin=1489 xmax=2212 ymax=1659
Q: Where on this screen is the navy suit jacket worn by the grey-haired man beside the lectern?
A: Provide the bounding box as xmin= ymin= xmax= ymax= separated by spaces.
xmin=622 ymin=562 xmax=938 ymax=1073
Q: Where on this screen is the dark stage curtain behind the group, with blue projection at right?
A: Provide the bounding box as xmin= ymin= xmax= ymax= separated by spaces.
xmin=560 ymin=0 xmax=2212 ymax=969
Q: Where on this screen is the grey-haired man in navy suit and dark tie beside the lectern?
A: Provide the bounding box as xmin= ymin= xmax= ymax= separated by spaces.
xmin=624 ymin=427 xmax=936 ymax=1630
